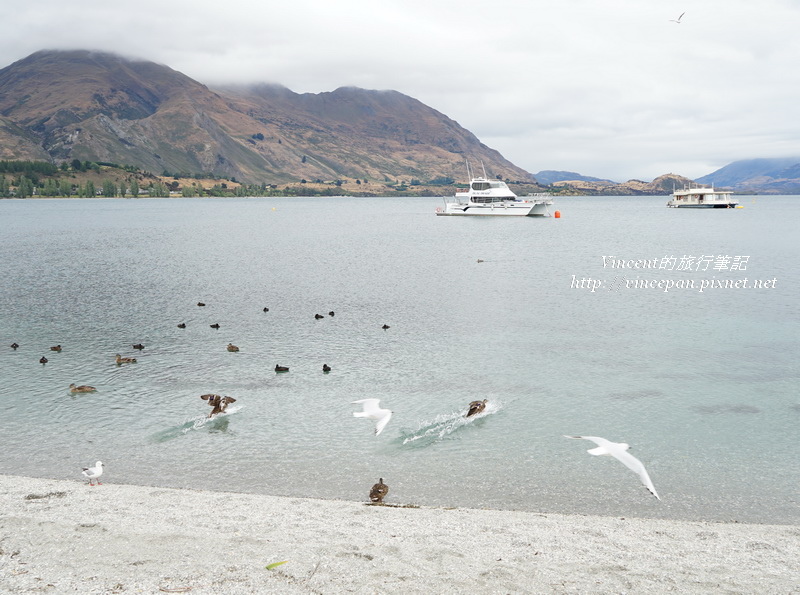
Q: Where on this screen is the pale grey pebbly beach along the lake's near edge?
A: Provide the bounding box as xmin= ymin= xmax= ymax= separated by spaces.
xmin=0 ymin=475 xmax=800 ymax=594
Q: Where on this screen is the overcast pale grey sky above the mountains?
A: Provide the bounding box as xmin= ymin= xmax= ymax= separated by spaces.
xmin=0 ymin=0 xmax=800 ymax=181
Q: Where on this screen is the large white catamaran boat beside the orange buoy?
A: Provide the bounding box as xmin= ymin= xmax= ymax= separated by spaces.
xmin=436 ymin=164 xmax=553 ymax=217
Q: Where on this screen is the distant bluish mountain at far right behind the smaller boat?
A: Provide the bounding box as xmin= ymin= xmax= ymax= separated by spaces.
xmin=697 ymin=157 xmax=800 ymax=194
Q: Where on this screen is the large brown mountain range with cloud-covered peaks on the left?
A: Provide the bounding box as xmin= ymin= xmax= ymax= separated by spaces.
xmin=0 ymin=50 xmax=535 ymax=183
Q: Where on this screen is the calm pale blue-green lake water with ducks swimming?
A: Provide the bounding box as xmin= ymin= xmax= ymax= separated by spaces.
xmin=0 ymin=197 xmax=800 ymax=524
